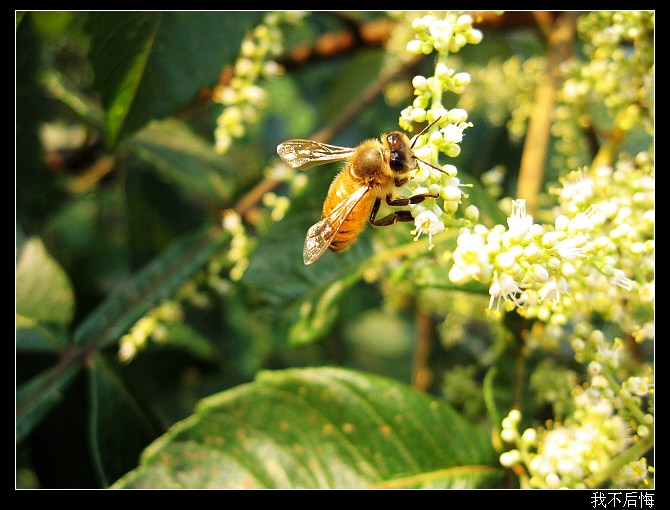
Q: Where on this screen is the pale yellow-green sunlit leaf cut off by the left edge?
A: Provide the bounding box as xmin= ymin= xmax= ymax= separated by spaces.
xmin=16 ymin=237 xmax=74 ymax=329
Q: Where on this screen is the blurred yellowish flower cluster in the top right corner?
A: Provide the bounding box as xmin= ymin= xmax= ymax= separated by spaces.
xmin=552 ymin=11 xmax=655 ymax=172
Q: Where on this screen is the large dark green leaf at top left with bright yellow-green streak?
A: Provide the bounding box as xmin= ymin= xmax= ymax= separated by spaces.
xmin=86 ymin=11 xmax=262 ymax=147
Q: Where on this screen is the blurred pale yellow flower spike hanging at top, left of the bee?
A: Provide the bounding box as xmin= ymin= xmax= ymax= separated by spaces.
xmin=212 ymin=11 xmax=304 ymax=154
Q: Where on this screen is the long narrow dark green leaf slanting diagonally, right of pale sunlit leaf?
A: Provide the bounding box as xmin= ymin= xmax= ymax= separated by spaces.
xmin=74 ymin=229 xmax=228 ymax=349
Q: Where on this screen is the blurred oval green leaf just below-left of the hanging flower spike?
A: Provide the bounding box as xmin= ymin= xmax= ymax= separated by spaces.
xmin=126 ymin=119 xmax=236 ymax=203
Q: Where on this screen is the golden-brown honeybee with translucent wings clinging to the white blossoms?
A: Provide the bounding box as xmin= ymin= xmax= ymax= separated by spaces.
xmin=277 ymin=119 xmax=446 ymax=264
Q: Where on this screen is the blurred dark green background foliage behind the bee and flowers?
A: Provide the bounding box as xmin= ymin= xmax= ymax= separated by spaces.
xmin=16 ymin=11 xmax=656 ymax=488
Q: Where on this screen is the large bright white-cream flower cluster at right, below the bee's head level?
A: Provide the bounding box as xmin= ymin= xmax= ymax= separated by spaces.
xmin=449 ymin=149 xmax=654 ymax=324
